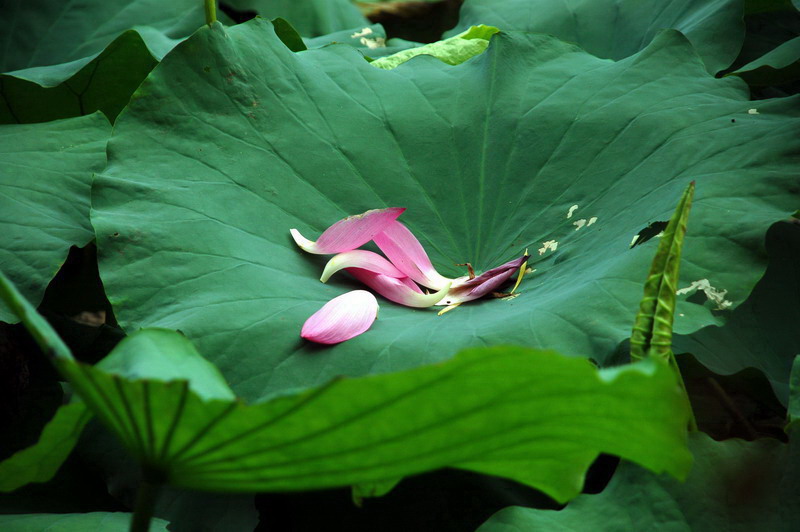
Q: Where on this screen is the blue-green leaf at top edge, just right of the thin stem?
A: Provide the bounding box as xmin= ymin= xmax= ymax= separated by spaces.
xmin=226 ymin=0 xmax=370 ymax=37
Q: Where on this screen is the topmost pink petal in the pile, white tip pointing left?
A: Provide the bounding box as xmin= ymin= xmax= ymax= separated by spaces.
xmin=289 ymin=207 xmax=405 ymax=255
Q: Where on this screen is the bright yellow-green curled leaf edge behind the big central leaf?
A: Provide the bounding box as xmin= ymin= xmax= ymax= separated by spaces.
xmin=371 ymin=26 xmax=500 ymax=70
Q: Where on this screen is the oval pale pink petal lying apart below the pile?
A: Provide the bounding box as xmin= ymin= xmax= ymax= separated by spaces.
xmin=300 ymin=290 xmax=378 ymax=344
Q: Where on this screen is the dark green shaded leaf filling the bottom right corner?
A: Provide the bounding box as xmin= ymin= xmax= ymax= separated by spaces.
xmin=478 ymin=432 xmax=800 ymax=532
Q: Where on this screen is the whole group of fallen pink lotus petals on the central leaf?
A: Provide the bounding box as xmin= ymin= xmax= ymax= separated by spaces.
xmin=291 ymin=207 xmax=528 ymax=344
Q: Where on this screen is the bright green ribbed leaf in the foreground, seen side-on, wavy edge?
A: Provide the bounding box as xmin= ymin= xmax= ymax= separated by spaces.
xmin=0 ymin=270 xmax=691 ymax=502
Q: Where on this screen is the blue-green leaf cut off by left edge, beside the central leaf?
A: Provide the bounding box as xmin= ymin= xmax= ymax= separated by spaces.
xmin=0 ymin=113 xmax=111 ymax=321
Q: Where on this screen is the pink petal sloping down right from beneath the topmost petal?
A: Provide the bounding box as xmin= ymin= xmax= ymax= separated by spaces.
xmin=373 ymin=220 xmax=453 ymax=290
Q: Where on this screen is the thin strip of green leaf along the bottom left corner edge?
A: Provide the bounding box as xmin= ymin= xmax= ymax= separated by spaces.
xmin=0 ymin=512 xmax=169 ymax=532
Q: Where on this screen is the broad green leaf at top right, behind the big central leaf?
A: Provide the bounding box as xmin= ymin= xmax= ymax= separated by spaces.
xmin=445 ymin=0 xmax=744 ymax=73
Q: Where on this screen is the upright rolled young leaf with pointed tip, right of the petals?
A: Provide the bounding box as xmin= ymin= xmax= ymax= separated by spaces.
xmin=631 ymin=181 xmax=695 ymax=361
